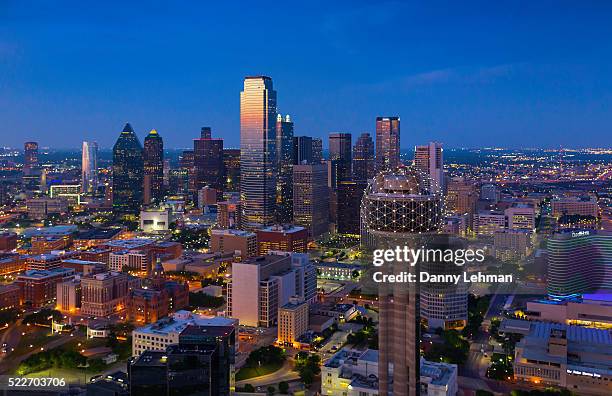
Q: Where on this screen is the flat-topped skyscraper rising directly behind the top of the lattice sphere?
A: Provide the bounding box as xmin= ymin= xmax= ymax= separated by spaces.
xmin=376 ymin=117 xmax=401 ymax=171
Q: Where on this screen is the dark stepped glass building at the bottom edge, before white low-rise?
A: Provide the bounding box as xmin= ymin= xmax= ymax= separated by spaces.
xmin=128 ymin=326 xmax=236 ymax=396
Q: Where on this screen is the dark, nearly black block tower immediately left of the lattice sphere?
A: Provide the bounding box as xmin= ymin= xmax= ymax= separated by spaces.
xmin=336 ymin=180 xmax=367 ymax=235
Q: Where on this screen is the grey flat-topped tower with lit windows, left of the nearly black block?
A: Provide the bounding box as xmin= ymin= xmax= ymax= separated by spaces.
xmin=293 ymin=164 xmax=329 ymax=238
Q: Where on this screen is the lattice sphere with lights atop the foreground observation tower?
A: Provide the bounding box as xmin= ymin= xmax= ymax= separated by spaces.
xmin=361 ymin=166 xmax=444 ymax=236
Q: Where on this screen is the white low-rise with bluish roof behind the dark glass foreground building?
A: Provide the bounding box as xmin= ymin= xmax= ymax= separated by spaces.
xmin=132 ymin=311 xmax=238 ymax=356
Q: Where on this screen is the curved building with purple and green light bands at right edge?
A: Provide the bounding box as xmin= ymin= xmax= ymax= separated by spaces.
xmin=546 ymin=230 xmax=612 ymax=298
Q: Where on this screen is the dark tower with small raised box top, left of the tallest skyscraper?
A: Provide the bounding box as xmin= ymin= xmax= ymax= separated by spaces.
xmin=193 ymin=127 xmax=225 ymax=191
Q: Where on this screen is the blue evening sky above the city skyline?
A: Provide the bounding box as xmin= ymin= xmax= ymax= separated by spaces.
xmin=0 ymin=0 xmax=612 ymax=148
